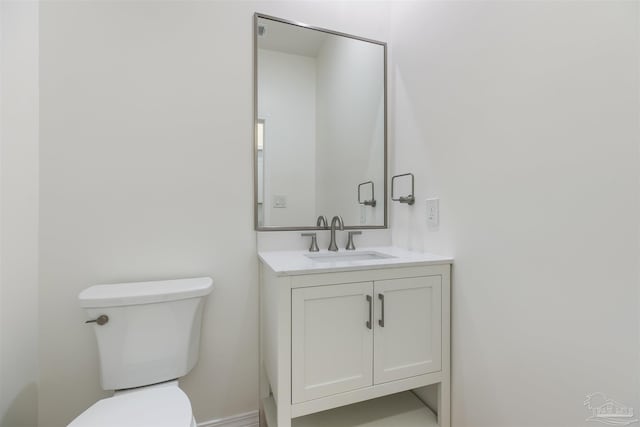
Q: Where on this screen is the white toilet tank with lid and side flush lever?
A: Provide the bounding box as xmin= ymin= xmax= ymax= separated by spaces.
xmin=78 ymin=277 xmax=213 ymax=390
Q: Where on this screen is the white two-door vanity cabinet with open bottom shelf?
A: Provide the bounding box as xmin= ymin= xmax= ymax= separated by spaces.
xmin=260 ymin=249 xmax=450 ymax=427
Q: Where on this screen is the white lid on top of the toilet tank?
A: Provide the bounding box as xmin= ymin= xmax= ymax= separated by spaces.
xmin=78 ymin=277 xmax=213 ymax=308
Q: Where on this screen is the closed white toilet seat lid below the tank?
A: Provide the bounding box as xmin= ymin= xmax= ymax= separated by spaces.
xmin=68 ymin=387 xmax=193 ymax=427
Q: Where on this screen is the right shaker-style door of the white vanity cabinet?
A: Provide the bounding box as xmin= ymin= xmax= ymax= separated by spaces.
xmin=374 ymin=276 xmax=442 ymax=384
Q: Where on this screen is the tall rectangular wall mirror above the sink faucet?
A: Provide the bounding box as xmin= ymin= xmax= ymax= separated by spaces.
xmin=254 ymin=14 xmax=387 ymax=230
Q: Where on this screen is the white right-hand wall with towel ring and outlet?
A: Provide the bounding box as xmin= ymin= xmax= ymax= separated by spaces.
xmin=390 ymin=2 xmax=640 ymax=427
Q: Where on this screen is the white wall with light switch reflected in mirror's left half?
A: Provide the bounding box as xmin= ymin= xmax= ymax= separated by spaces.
xmin=258 ymin=49 xmax=316 ymax=226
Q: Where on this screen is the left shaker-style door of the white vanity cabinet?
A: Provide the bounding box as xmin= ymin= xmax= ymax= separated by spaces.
xmin=291 ymin=282 xmax=374 ymax=403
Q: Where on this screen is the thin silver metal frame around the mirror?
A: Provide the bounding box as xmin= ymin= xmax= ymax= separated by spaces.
xmin=252 ymin=12 xmax=389 ymax=231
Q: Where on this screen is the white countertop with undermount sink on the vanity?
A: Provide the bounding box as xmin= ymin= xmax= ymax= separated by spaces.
xmin=258 ymin=246 xmax=453 ymax=276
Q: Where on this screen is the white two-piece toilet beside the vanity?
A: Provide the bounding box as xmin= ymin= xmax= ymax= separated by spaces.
xmin=69 ymin=277 xmax=213 ymax=427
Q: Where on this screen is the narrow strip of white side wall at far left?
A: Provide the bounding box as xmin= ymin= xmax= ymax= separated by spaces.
xmin=0 ymin=1 xmax=38 ymax=427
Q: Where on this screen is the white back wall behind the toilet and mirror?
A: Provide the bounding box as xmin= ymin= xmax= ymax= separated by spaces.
xmin=39 ymin=1 xmax=389 ymax=427
